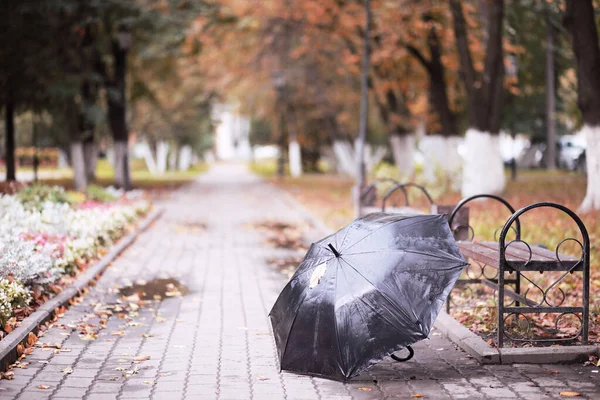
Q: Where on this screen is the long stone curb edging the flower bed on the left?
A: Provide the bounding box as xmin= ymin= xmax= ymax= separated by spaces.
xmin=0 ymin=208 xmax=163 ymax=371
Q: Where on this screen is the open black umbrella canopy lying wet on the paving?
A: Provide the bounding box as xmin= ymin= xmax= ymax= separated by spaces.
xmin=269 ymin=213 xmax=467 ymax=380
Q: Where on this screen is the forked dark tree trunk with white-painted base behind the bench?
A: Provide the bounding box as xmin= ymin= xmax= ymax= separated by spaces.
xmin=450 ymin=0 xmax=505 ymax=196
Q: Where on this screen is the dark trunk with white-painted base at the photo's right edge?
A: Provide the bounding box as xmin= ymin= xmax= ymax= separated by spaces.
xmin=563 ymin=0 xmax=600 ymax=212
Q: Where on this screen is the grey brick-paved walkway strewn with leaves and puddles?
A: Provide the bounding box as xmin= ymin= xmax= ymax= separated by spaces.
xmin=0 ymin=165 xmax=600 ymax=400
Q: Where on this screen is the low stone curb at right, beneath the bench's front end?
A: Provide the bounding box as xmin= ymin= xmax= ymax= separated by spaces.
xmin=434 ymin=311 xmax=599 ymax=364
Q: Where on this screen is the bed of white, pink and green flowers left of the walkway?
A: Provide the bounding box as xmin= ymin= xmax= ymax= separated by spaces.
xmin=0 ymin=186 xmax=151 ymax=338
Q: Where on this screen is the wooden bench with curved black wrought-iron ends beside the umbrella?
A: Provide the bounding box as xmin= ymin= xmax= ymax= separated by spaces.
xmin=446 ymin=195 xmax=590 ymax=347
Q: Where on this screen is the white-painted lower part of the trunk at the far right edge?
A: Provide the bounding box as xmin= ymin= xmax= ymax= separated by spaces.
xmin=579 ymin=125 xmax=600 ymax=212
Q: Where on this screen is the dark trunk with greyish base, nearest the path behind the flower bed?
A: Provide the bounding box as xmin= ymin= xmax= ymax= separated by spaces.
xmin=107 ymin=40 xmax=131 ymax=190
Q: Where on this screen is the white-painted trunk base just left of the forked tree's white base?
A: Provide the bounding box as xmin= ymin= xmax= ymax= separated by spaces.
xmin=419 ymin=135 xmax=462 ymax=190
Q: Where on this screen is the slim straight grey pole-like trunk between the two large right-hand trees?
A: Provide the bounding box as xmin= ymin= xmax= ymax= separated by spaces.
xmin=546 ymin=11 xmax=556 ymax=170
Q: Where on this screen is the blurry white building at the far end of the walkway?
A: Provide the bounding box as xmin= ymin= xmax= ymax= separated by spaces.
xmin=212 ymin=104 xmax=252 ymax=161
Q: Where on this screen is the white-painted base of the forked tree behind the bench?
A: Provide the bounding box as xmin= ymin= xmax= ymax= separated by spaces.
xmin=462 ymin=128 xmax=506 ymax=197
